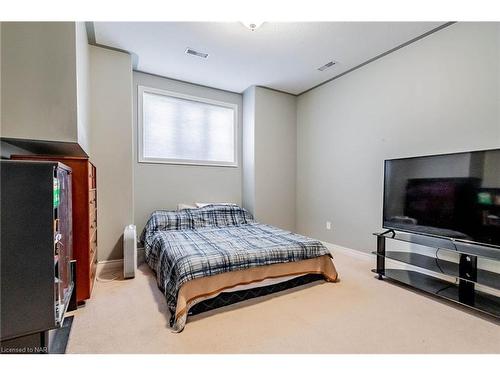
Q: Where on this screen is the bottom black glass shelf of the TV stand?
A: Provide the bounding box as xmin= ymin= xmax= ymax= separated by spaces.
xmin=372 ymin=269 xmax=500 ymax=318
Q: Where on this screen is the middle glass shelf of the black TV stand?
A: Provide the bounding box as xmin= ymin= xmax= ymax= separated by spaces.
xmin=372 ymin=251 xmax=500 ymax=289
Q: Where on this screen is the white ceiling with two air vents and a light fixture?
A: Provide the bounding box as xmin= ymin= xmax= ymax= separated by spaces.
xmin=94 ymin=22 xmax=444 ymax=94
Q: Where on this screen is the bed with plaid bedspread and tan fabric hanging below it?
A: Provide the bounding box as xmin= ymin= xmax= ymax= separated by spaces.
xmin=141 ymin=204 xmax=338 ymax=332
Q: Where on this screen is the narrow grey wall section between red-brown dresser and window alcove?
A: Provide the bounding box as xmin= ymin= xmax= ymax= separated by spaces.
xmin=90 ymin=46 xmax=134 ymax=261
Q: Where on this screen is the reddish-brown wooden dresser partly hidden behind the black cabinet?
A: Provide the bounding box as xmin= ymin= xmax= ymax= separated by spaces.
xmin=11 ymin=155 xmax=97 ymax=302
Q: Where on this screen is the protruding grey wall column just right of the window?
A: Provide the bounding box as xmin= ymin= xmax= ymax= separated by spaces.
xmin=243 ymin=87 xmax=297 ymax=231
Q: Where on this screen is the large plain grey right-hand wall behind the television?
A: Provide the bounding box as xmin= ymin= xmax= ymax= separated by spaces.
xmin=297 ymin=23 xmax=500 ymax=251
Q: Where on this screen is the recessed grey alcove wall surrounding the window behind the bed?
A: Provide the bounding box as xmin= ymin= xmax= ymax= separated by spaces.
xmin=133 ymin=72 xmax=242 ymax=230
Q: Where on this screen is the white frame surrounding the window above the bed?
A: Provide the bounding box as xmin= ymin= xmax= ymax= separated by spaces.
xmin=137 ymin=85 xmax=239 ymax=168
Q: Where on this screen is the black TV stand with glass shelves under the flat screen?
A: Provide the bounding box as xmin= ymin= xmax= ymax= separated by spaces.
xmin=372 ymin=230 xmax=500 ymax=319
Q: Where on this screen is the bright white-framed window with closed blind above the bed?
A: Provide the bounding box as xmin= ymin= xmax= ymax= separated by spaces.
xmin=138 ymin=86 xmax=238 ymax=167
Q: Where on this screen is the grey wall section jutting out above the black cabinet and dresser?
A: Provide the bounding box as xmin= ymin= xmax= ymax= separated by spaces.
xmin=1 ymin=22 xmax=89 ymax=153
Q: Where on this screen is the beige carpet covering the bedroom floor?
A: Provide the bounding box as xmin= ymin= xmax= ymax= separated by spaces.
xmin=67 ymin=248 xmax=500 ymax=353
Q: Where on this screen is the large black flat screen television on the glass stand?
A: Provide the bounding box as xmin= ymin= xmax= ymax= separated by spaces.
xmin=383 ymin=149 xmax=500 ymax=248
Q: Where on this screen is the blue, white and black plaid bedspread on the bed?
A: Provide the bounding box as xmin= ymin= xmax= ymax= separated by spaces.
xmin=141 ymin=206 xmax=329 ymax=320
